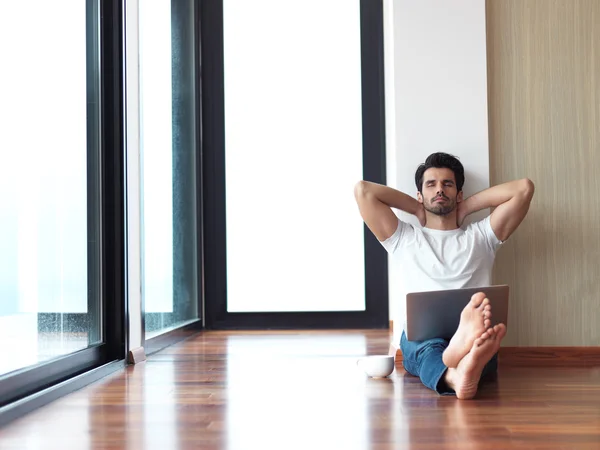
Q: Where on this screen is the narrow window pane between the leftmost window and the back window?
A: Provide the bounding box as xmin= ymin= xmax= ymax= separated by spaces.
xmin=139 ymin=0 xmax=199 ymax=339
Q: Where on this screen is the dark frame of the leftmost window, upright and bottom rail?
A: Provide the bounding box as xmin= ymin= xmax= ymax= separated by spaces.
xmin=0 ymin=0 xmax=127 ymax=414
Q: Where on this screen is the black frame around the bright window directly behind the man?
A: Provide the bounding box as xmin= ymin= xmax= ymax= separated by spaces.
xmin=201 ymin=0 xmax=389 ymax=329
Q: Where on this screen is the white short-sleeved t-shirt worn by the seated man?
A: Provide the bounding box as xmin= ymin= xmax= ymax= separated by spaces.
xmin=381 ymin=216 xmax=502 ymax=334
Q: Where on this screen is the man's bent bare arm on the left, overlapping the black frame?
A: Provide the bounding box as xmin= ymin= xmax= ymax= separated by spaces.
xmin=354 ymin=181 xmax=425 ymax=242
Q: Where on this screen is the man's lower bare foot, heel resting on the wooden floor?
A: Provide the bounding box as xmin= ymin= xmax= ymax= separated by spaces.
xmin=445 ymin=323 xmax=506 ymax=400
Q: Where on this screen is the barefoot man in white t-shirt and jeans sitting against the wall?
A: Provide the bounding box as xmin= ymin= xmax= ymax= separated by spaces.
xmin=355 ymin=153 xmax=534 ymax=399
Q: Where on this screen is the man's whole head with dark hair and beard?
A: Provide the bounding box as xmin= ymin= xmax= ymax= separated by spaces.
xmin=415 ymin=153 xmax=465 ymax=216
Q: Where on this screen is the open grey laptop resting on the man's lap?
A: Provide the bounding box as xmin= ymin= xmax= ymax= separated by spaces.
xmin=406 ymin=285 xmax=509 ymax=341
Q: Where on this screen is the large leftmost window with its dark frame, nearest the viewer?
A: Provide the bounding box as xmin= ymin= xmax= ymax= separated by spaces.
xmin=0 ymin=0 xmax=124 ymax=406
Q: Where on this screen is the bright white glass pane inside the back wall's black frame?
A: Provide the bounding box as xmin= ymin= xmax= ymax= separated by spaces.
xmin=223 ymin=0 xmax=365 ymax=312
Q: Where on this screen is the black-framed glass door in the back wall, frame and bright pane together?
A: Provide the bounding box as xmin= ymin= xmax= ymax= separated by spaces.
xmin=202 ymin=0 xmax=388 ymax=327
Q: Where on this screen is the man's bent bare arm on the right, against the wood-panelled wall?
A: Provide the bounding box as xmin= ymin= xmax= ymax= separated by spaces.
xmin=459 ymin=178 xmax=535 ymax=242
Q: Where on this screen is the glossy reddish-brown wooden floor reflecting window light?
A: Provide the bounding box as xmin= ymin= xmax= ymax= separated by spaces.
xmin=0 ymin=331 xmax=600 ymax=450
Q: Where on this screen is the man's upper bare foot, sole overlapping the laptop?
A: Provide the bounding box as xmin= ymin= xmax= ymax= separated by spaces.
xmin=442 ymin=292 xmax=492 ymax=367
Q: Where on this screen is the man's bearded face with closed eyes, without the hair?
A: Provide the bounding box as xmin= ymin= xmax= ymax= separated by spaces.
xmin=417 ymin=167 xmax=462 ymax=216
